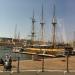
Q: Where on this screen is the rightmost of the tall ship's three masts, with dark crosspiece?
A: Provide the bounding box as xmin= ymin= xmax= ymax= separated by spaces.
xmin=52 ymin=5 xmax=57 ymax=48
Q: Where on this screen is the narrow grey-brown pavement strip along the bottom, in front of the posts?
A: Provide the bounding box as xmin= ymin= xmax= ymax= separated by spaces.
xmin=0 ymin=71 xmax=75 ymax=75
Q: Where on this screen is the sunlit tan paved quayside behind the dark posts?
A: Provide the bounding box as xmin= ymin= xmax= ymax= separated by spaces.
xmin=0 ymin=56 xmax=75 ymax=75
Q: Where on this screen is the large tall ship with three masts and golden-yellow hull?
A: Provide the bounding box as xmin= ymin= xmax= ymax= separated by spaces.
xmin=12 ymin=5 xmax=73 ymax=57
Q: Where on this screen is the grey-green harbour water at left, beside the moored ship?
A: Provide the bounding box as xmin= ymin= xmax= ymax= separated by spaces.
xmin=0 ymin=47 xmax=31 ymax=60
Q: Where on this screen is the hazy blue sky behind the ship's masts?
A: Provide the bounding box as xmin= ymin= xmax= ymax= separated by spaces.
xmin=0 ymin=0 xmax=75 ymax=40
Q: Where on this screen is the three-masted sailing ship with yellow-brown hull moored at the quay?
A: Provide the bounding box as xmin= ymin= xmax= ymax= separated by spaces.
xmin=23 ymin=6 xmax=64 ymax=57
